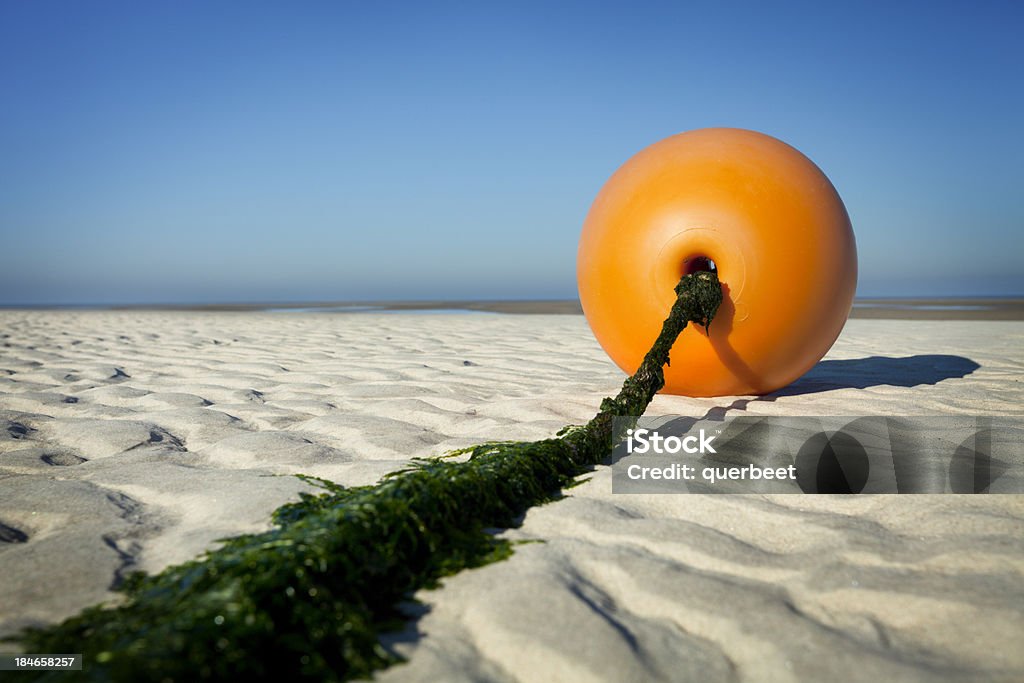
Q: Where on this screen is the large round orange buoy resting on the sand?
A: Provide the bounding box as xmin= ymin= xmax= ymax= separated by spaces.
xmin=577 ymin=128 xmax=857 ymax=396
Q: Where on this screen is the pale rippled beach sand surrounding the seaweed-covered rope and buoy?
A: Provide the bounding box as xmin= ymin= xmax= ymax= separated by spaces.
xmin=0 ymin=311 xmax=1024 ymax=683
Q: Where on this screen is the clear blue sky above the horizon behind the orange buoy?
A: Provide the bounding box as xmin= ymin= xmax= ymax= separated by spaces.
xmin=0 ymin=0 xmax=1024 ymax=303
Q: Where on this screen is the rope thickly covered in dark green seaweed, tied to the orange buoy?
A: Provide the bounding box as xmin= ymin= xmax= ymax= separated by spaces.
xmin=16 ymin=272 xmax=722 ymax=681
